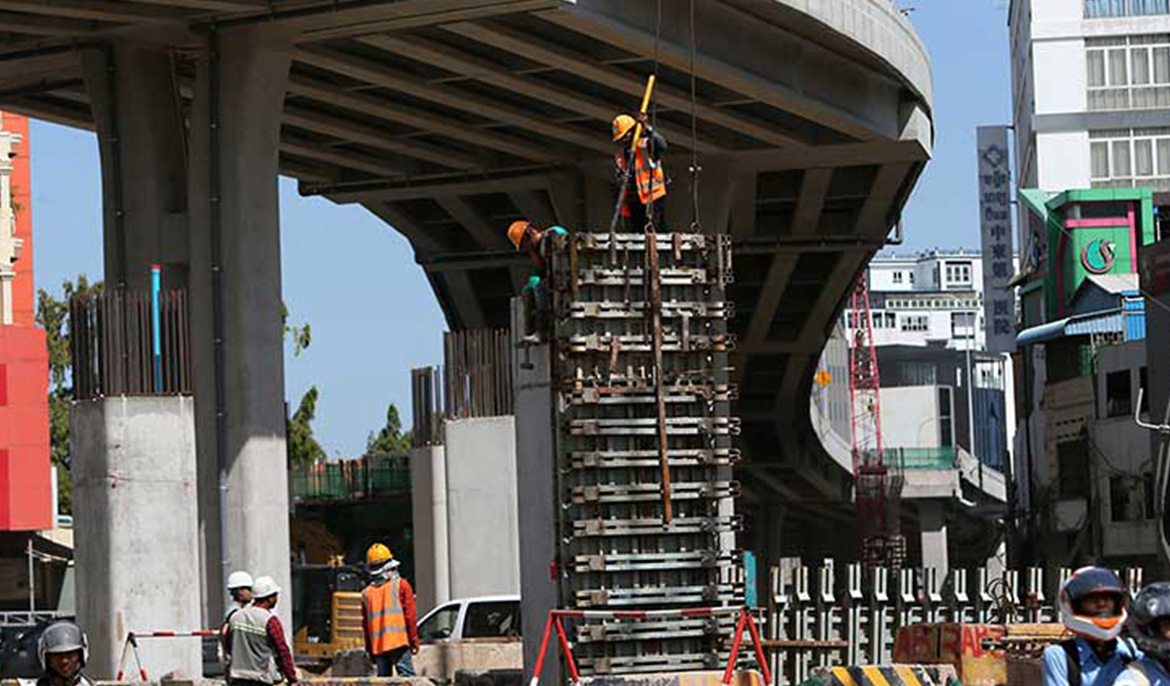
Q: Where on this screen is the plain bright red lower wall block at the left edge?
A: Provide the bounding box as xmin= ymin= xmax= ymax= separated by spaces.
xmin=0 ymin=325 xmax=54 ymax=531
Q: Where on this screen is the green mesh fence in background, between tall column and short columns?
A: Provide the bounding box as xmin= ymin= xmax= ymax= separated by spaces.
xmin=289 ymin=459 xmax=411 ymax=502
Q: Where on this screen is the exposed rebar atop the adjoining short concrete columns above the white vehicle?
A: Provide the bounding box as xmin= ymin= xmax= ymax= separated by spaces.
xmin=411 ymin=329 xmax=514 ymax=447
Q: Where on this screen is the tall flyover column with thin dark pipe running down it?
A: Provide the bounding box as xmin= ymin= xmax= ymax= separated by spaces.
xmin=188 ymin=29 xmax=293 ymax=630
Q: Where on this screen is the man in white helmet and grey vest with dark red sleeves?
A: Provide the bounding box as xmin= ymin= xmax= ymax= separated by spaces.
xmin=225 ymin=576 xmax=296 ymax=686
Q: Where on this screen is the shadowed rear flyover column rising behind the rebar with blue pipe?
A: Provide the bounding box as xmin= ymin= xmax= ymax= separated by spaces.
xmin=81 ymin=40 xmax=188 ymax=289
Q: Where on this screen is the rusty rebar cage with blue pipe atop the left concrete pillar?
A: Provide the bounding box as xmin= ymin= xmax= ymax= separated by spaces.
xmin=69 ymin=289 xmax=191 ymax=400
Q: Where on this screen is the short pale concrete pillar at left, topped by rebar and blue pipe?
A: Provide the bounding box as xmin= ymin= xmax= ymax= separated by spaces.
xmin=70 ymin=396 xmax=206 ymax=679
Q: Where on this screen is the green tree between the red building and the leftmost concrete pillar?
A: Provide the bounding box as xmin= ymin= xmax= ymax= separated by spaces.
xmin=36 ymin=274 xmax=102 ymax=514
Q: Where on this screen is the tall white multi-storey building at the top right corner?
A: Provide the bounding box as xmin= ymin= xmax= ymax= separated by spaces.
xmin=1010 ymin=0 xmax=1170 ymax=197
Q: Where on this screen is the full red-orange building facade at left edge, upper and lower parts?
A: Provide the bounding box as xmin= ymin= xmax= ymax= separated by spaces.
xmin=0 ymin=112 xmax=54 ymax=531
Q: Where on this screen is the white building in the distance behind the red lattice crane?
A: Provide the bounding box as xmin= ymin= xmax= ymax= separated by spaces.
xmin=846 ymin=249 xmax=984 ymax=350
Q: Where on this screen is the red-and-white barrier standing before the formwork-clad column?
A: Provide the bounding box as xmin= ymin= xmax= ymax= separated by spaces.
xmin=529 ymin=606 xmax=772 ymax=686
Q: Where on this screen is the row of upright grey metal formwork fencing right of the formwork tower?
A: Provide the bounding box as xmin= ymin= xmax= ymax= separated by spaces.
xmin=766 ymin=561 xmax=1142 ymax=685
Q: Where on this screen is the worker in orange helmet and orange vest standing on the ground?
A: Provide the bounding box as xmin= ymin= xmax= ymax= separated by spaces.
xmin=362 ymin=543 xmax=419 ymax=677
